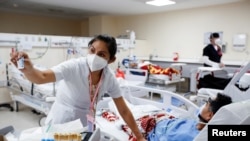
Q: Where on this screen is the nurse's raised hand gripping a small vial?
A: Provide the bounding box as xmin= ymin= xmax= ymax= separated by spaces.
xmin=10 ymin=51 xmax=33 ymax=73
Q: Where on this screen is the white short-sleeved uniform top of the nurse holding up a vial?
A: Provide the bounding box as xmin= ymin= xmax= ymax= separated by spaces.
xmin=46 ymin=57 xmax=121 ymax=126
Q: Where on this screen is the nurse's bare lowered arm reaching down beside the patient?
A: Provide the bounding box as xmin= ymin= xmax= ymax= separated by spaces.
xmin=113 ymin=97 xmax=145 ymax=141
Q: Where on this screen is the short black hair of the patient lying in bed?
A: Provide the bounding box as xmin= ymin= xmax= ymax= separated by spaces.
xmin=209 ymin=93 xmax=232 ymax=114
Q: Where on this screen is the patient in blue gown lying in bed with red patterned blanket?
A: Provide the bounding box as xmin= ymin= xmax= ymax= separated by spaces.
xmin=123 ymin=93 xmax=232 ymax=141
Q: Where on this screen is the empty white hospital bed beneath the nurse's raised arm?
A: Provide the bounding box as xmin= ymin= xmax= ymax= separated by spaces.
xmin=6 ymin=64 xmax=58 ymax=125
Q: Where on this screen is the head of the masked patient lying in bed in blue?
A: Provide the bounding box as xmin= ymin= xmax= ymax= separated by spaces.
xmin=199 ymin=93 xmax=232 ymax=130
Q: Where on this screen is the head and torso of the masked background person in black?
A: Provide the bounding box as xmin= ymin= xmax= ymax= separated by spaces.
xmin=202 ymin=32 xmax=225 ymax=68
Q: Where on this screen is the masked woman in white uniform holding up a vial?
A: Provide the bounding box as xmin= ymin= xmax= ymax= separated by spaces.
xmin=11 ymin=35 xmax=145 ymax=141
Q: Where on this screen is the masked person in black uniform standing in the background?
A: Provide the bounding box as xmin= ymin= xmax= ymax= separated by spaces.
xmin=198 ymin=33 xmax=231 ymax=90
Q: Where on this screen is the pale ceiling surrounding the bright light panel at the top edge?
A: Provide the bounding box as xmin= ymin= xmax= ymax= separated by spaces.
xmin=0 ymin=0 xmax=243 ymax=19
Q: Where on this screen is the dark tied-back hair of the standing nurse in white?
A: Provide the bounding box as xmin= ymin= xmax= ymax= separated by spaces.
xmin=88 ymin=34 xmax=117 ymax=59
